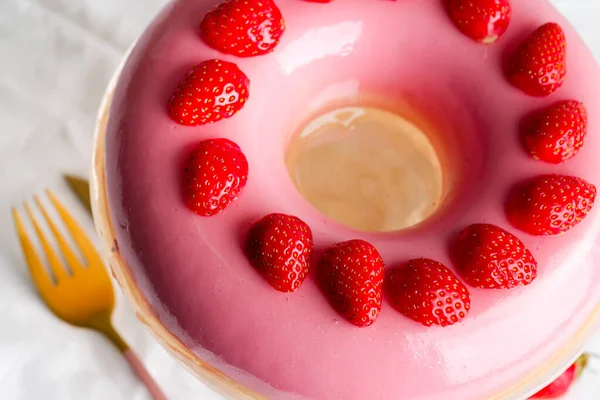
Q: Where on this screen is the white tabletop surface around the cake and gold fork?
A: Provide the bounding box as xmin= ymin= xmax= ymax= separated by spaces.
xmin=0 ymin=0 xmax=600 ymax=400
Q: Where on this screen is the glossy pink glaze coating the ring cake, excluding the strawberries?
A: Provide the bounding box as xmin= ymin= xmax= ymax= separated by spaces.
xmin=106 ymin=0 xmax=600 ymax=400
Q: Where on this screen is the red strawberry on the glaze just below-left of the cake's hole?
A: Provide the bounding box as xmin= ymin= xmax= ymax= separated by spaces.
xmin=246 ymin=214 xmax=313 ymax=292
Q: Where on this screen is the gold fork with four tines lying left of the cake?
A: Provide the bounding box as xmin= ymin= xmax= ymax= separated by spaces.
xmin=13 ymin=191 xmax=166 ymax=400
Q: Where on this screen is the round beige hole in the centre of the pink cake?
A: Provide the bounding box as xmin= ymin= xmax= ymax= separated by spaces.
xmin=286 ymin=107 xmax=444 ymax=232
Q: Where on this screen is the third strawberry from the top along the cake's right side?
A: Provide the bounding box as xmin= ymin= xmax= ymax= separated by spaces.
xmin=522 ymin=100 xmax=587 ymax=164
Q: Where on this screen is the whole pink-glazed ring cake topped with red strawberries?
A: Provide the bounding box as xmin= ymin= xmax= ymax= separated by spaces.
xmin=93 ymin=0 xmax=600 ymax=400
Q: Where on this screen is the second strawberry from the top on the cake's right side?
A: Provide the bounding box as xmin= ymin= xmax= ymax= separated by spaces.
xmin=509 ymin=22 xmax=567 ymax=97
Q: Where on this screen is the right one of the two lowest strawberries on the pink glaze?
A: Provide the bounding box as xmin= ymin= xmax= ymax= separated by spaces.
xmin=386 ymin=258 xmax=471 ymax=326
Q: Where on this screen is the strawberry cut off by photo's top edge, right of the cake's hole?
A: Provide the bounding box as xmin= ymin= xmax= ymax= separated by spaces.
xmin=447 ymin=0 xmax=512 ymax=43
